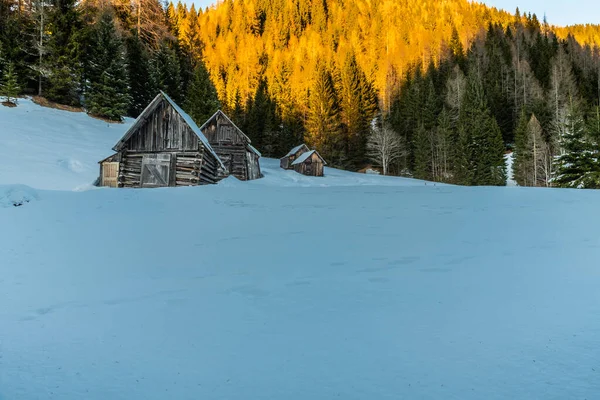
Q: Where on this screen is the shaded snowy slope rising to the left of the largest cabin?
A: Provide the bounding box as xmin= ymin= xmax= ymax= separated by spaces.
xmin=0 ymin=99 xmax=133 ymax=190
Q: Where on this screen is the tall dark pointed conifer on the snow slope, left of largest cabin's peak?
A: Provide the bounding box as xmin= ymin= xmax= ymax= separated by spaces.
xmin=85 ymin=11 xmax=130 ymax=121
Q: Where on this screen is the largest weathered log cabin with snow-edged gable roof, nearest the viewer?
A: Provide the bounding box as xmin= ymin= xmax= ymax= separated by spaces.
xmin=100 ymin=92 xmax=225 ymax=187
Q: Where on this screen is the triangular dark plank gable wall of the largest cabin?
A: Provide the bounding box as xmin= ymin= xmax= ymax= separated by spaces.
xmin=123 ymin=99 xmax=200 ymax=152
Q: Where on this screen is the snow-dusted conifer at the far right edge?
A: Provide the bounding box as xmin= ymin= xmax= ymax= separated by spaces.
xmin=554 ymin=105 xmax=600 ymax=189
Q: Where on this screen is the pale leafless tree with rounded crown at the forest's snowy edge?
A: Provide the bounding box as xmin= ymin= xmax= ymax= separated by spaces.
xmin=367 ymin=124 xmax=406 ymax=175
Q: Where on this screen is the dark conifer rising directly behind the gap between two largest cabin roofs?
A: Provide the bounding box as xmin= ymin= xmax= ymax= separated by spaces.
xmin=183 ymin=61 xmax=221 ymax=125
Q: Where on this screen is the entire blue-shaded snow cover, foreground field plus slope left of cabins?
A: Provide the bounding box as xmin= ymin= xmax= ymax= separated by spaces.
xmin=0 ymin=101 xmax=600 ymax=400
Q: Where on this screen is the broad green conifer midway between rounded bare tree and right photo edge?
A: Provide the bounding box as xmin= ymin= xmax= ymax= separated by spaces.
xmin=455 ymin=73 xmax=506 ymax=186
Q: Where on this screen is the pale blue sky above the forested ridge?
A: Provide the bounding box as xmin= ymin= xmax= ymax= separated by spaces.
xmin=194 ymin=0 xmax=600 ymax=25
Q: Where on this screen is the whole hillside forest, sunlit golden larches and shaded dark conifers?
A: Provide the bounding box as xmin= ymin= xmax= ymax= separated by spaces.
xmin=0 ymin=0 xmax=600 ymax=188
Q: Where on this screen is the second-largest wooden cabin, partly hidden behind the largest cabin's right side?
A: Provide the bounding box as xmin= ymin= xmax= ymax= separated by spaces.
xmin=200 ymin=110 xmax=262 ymax=181
